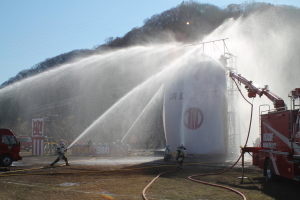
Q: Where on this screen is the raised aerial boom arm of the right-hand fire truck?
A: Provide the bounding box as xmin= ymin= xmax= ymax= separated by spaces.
xmin=229 ymin=71 xmax=286 ymax=111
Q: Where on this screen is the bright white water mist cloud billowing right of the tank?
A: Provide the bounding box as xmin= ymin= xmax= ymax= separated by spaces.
xmin=205 ymin=7 xmax=300 ymax=146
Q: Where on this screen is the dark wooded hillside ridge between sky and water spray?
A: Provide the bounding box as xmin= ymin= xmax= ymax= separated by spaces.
xmin=1 ymin=1 xmax=292 ymax=88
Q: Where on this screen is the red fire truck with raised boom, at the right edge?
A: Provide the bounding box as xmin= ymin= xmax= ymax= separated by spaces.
xmin=229 ymin=72 xmax=300 ymax=181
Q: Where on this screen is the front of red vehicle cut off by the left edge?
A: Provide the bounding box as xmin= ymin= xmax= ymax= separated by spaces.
xmin=0 ymin=129 xmax=22 ymax=167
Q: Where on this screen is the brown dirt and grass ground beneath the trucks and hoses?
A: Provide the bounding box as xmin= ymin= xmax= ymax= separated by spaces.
xmin=0 ymin=152 xmax=300 ymax=200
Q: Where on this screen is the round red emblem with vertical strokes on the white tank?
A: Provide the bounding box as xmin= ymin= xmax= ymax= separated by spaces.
xmin=183 ymin=107 xmax=204 ymax=130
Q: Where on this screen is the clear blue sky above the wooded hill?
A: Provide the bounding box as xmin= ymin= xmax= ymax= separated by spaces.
xmin=0 ymin=0 xmax=300 ymax=84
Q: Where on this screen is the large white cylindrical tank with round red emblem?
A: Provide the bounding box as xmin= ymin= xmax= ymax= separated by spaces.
xmin=163 ymin=59 xmax=227 ymax=155
